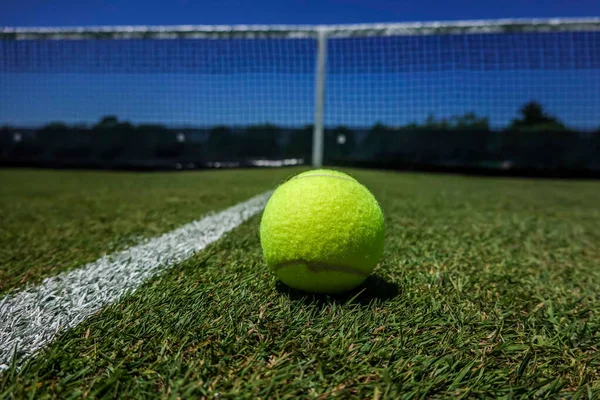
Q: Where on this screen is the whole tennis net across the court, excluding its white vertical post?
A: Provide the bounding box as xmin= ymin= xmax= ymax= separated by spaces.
xmin=0 ymin=19 xmax=600 ymax=168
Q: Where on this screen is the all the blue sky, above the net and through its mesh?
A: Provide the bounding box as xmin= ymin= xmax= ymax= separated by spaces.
xmin=0 ymin=0 xmax=600 ymax=129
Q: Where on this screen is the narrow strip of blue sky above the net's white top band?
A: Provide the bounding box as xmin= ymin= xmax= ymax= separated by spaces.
xmin=0 ymin=0 xmax=600 ymax=26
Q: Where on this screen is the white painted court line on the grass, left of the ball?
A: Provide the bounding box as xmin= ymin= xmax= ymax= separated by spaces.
xmin=0 ymin=191 xmax=272 ymax=371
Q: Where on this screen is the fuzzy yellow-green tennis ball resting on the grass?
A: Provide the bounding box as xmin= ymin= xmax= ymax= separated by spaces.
xmin=260 ymin=169 xmax=385 ymax=294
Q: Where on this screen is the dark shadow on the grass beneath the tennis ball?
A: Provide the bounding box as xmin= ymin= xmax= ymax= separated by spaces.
xmin=275 ymin=275 xmax=399 ymax=305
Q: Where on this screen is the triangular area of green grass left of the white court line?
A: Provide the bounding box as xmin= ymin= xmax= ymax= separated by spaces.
xmin=0 ymin=169 xmax=299 ymax=294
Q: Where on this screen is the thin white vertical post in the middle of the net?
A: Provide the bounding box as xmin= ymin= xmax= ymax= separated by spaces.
xmin=312 ymin=28 xmax=327 ymax=168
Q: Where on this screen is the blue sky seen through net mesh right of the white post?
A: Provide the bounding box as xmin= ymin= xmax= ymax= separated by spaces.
xmin=325 ymin=32 xmax=600 ymax=130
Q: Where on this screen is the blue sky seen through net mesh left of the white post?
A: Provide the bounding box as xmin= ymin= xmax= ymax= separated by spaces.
xmin=0 ymin=39 xmax=315 ymax=127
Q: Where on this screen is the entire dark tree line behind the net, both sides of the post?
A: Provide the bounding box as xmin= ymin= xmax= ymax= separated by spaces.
xmin=0 ymin=102 xmax=600 ymax=170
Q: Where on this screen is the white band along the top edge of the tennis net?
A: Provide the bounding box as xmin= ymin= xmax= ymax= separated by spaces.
xmin=0 ymin=18 xmax=600 ymax=40
